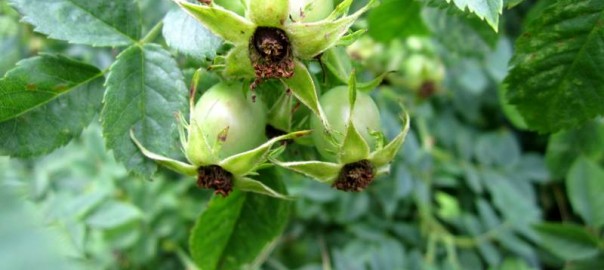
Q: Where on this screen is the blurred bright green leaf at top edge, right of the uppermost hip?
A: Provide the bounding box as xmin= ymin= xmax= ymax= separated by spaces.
xmin=367 ymin=0 xmax=429 ymax=43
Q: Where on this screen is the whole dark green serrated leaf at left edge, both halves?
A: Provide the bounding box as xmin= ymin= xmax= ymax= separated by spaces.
xmin=0 ymin=55 xmax=103 ymax=157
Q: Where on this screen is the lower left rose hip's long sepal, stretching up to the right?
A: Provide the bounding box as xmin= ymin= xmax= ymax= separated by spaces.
xmin=219 ymin=131 xmax=310 ymax=176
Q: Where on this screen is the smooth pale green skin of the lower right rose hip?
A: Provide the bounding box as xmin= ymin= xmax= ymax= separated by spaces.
xmin=310 ymin=86 xmax=381 ymax=161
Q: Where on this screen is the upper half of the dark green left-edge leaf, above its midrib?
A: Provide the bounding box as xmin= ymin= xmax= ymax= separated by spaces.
xmin=0 ymin=55 xmax=102 ymax=122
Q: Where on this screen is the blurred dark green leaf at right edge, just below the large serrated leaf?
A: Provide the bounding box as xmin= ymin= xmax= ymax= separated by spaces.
xmin=545 ymin=121 xmax=604 ymax=178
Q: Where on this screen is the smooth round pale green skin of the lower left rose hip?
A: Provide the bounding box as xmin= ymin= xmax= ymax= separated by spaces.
xmin=188 ymin=82 xmax=266 ymax=158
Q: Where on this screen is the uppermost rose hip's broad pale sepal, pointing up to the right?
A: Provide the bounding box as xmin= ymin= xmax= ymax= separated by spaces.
xmin=285 ymin=0 xmax=375 ymax=59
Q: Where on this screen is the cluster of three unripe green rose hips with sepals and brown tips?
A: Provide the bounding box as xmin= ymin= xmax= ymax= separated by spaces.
xmin=132 ymin=0 xmax=409 ymax=197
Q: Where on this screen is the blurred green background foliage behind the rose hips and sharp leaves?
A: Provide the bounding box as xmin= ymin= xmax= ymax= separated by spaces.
xmin=0 ymin=0 xmax=604 ymax=270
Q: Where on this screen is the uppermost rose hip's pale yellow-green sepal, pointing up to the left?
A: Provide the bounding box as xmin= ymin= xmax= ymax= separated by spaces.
xmin=173 ymin=0 xmax=256 ymax=46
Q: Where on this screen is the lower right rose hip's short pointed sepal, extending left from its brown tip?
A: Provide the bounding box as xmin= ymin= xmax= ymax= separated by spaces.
xmin=271 ymin=160 xmax=344 ymax=184
